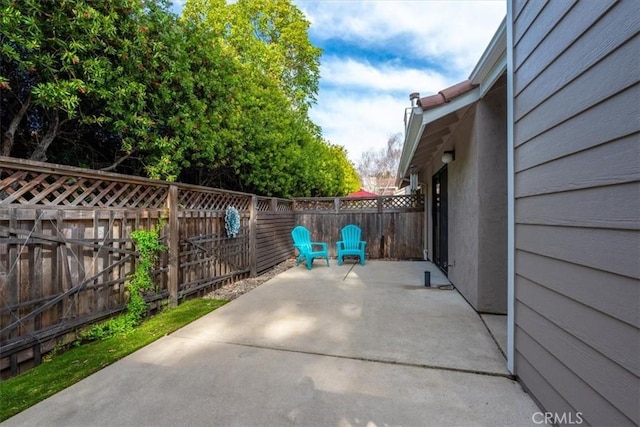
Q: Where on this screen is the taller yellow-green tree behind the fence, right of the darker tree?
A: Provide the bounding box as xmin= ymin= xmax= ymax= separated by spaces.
xmin=183 ymin=0 xmax=359 ymax=197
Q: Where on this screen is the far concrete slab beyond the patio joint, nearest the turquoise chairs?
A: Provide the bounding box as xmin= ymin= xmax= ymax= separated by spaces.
xmin=175 ymin=260 xmax=508 ymax=375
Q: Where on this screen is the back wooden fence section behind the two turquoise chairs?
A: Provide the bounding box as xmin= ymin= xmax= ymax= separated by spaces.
xmin=294 ymin=194 xmax=424 ymax=260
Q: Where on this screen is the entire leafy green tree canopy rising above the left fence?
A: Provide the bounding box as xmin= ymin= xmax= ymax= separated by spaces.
xmin=0 ymin=0 xmax=357 ymax=196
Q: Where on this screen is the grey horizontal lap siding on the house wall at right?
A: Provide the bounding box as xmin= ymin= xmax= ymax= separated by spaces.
xmin=508 ymin=0 xmax=640 ymax=425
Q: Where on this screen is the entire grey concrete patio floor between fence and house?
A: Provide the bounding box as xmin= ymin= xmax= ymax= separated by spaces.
xmin=4 ymin=261 xmax=539 ymax=427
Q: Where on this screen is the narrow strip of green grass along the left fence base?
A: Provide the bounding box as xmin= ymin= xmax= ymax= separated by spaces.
xmin=0 ymin=299 xmax=227 ymax=421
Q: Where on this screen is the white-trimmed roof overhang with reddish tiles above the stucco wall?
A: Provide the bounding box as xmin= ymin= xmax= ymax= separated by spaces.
xmin=396 ymin=18 xmax=507 ymax=188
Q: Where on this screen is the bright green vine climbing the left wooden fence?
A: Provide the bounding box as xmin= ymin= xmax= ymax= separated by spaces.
xmin=80 ymin=222 xmax=165 ymax=341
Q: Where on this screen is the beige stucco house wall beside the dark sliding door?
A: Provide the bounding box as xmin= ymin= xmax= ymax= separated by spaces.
xmin=428 ymin=82 xmax=507 ymax=314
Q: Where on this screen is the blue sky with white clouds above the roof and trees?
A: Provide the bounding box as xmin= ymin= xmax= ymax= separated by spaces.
xmin=173 ymin=0 xmax=506 ymax=164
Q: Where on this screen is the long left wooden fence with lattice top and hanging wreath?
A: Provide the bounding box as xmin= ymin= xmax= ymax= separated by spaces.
xmin=0 ymin=157 xmax=294 ymax=378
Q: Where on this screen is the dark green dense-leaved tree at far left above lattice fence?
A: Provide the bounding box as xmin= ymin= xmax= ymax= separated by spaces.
xmin=0 ymin=0 xmax=233 ymax=180
